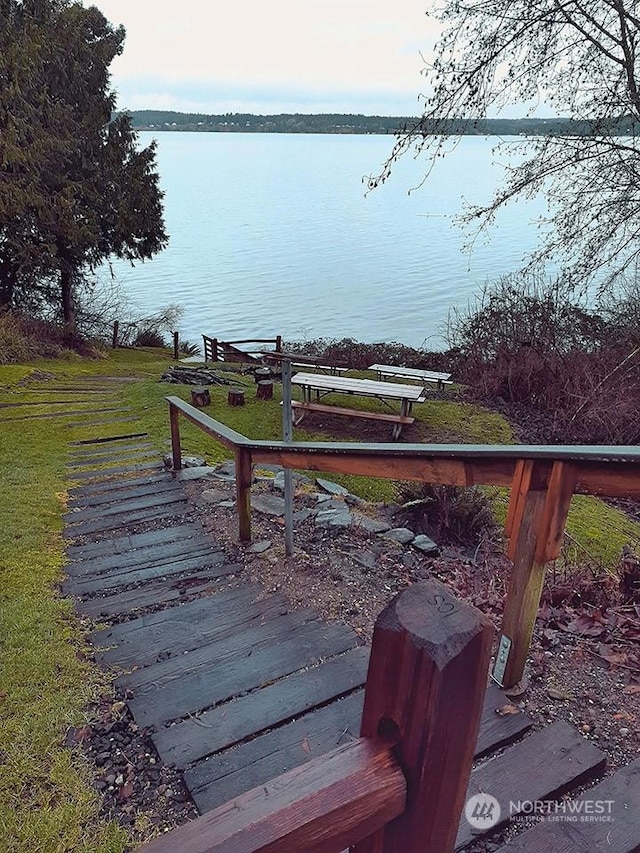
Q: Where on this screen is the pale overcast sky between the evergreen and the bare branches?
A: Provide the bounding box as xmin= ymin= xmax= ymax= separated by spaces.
xmin=85 ymin=0 xmax=436 ymax=115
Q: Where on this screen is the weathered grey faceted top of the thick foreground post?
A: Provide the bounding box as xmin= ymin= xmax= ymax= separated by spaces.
xmin=376 ymin=580 xmax=493 ymax=669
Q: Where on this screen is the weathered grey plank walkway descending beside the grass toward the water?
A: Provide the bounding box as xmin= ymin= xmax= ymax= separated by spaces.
xmin=57 ymin=402 xmax=640 ymax=853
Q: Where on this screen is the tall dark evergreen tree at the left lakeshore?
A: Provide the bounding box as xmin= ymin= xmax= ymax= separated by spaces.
xmin=0 ymin=0 xmax=167 ymax=335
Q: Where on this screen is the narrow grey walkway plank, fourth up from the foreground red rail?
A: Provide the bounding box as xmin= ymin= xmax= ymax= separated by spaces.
xmin=117 ymin=602 xmax=338 ymax=692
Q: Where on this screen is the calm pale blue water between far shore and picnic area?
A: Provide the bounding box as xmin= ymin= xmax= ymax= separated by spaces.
xmin=107 ymin=133 xmax=543 ymax=348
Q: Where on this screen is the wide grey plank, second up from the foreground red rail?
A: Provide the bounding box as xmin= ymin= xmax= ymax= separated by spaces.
xmin=153 ymin=646 xmax=369 ymax=770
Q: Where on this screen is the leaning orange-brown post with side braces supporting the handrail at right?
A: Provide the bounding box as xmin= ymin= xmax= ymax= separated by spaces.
xmin=493 ymin=460 xmax=576 ymax=687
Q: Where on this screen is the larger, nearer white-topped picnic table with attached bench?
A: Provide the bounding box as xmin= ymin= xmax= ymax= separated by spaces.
xmin=291 ymin=373 xmax=425 ymax=441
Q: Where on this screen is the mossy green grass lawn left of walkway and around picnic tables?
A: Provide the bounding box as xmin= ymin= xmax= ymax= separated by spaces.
xmin=0 ymin=350 xmax=640 ymax=853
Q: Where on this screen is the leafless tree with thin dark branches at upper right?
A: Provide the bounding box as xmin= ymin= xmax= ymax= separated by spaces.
xmin=370 ymin=0 xmax=640 ymax=289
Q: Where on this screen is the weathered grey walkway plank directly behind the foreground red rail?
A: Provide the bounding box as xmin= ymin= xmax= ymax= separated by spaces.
xmin=184 ymin=690 xmax=364 ymax=814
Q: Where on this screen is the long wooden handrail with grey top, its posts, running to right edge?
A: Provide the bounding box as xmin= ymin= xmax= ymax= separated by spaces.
xmin=167 ymin=397 xmax=640 ymax=687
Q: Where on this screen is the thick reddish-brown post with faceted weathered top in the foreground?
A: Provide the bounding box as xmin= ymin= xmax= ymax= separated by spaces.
xmin=352 ymin=581 xmax=493 ymax=853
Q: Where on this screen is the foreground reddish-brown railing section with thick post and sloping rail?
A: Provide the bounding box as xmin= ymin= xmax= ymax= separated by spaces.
xmin=141 ymin=581 xmax=493 ymax=853
